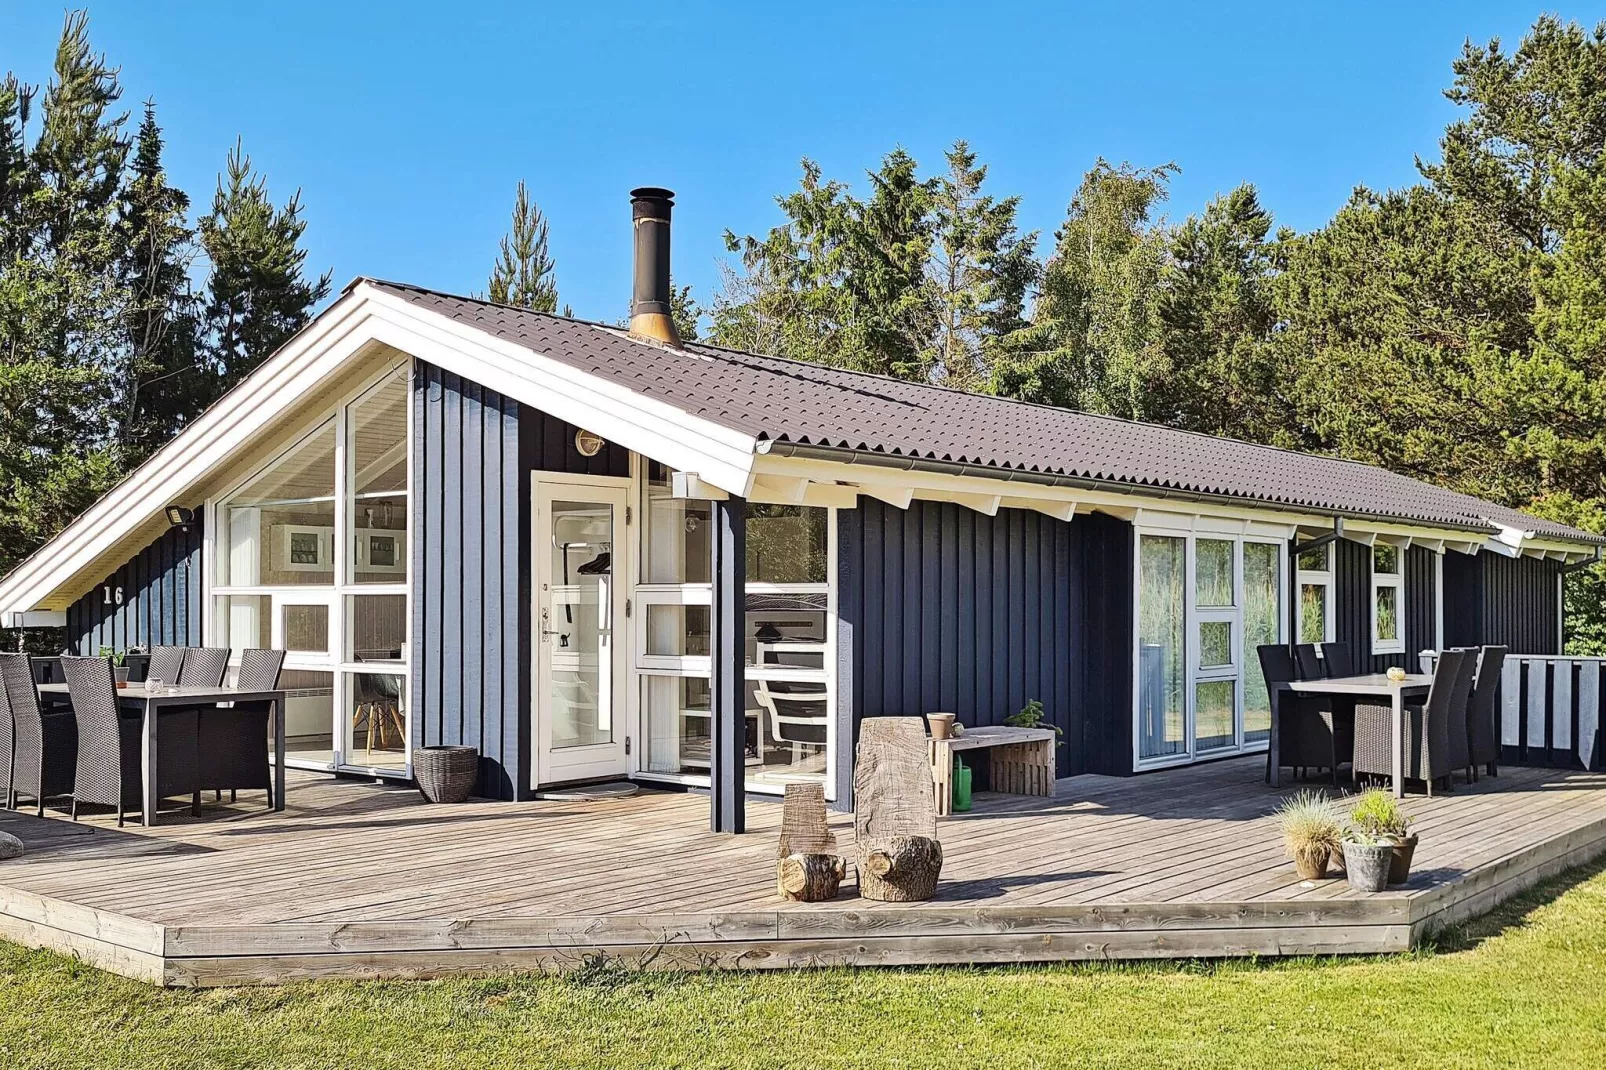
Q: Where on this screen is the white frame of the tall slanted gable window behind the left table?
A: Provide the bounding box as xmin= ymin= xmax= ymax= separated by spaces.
xmin=201 ymin=358 xmax=416 ymax=779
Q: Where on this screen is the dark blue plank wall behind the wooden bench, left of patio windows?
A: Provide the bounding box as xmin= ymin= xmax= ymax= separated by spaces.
xmin=837 ymin=498 xmax=1132 ymax=776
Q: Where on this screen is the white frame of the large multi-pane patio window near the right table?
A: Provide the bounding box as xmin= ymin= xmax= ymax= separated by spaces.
xmin=1131 ymin=525 xmax=1291 ymax=771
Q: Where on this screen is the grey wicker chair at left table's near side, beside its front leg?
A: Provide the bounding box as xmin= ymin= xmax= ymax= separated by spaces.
xmin=61 ymin=657 xmax=201 ymax=827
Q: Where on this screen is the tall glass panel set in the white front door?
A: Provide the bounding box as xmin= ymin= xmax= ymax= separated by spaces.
xmin=541 ymin=501 xmax=613 ymax=750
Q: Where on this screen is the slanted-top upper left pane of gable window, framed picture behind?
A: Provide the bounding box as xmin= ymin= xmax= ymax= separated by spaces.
xmin=217 ymin=421 xmax=334 ymax=586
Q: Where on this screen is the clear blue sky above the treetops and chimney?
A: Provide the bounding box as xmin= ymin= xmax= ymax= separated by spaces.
xmin=0 ymin=0 xmax=1598 ymax=320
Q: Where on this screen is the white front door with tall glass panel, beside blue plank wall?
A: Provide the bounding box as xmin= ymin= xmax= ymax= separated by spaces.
xmin=532 ymin=480 xmax=628 ymax=786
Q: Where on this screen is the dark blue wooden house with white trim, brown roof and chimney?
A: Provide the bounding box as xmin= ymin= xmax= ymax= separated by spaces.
xmin=0 ymin=188 xmax=1606 ymax=831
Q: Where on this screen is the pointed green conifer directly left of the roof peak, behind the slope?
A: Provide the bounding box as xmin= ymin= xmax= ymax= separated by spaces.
xmin=199 ymin=141 xmax=329 ymax=395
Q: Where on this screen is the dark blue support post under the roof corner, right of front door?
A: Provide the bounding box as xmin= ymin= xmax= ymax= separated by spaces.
xmin=708 ymin=495 xmax=747 ymax=832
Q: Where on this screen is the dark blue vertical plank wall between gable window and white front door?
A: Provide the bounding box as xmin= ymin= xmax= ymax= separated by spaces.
xmin=413 ymin=361 xmax=630 ymax=798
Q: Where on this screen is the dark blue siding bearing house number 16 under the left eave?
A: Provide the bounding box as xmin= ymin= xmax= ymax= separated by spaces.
xmin=67 ymin=520 xmax=201 ymax=655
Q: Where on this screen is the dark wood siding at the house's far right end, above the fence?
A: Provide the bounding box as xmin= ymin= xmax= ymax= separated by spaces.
xmin=1444 ymin=551 xmax=1561 ymax=654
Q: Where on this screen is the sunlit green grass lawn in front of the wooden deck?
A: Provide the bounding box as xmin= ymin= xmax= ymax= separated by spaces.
xmin=0 ymin=864 xmax=1606 ymax=1070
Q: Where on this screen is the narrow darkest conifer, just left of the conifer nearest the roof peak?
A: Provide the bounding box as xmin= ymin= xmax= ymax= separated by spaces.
xmin=119 ymin=101 xmax=207 ymax=464
